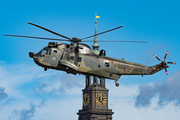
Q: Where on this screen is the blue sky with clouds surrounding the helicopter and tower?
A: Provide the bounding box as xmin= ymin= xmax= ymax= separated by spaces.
xmin=0 ymin=0 xmax=180 ymax=120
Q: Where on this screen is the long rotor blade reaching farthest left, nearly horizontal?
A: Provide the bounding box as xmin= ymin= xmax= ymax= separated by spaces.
xmin=4 ymin=34 xmax=69 ymax=41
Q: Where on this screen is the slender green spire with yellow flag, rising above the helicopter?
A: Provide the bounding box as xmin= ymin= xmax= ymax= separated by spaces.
xmin=92 ymin=13 xmax=100 ymax=54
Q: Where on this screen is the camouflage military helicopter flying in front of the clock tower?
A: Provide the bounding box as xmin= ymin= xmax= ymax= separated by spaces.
xmin=4 ymin=23 xmax=176 ymax=87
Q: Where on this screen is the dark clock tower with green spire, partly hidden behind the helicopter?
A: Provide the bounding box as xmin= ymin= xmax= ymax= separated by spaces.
xmin=77 ymin=14 xmax=113 ymax=120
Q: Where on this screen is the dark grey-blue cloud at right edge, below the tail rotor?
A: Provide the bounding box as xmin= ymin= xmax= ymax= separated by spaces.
xmin=135 ymin=71 xmax=180 ymax=109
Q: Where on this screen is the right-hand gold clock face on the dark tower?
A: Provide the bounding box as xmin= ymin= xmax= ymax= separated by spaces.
xmin=96 ymin=93 xmax=107 ymax=106
